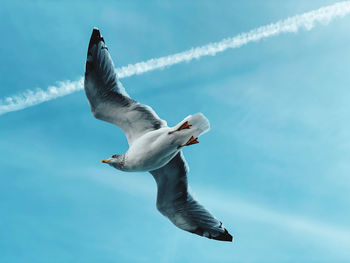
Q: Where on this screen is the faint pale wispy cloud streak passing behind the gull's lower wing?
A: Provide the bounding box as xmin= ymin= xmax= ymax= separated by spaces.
xmin=89 ymin=170 xmax=350 ymax=253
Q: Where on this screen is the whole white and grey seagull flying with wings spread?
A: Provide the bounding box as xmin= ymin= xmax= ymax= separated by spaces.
xmin=84 ymin=28 xmax=233 ymax=242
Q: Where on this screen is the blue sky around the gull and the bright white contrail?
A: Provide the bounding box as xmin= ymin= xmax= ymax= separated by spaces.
xmin=0 ymin=0 xmax=350 ymax=263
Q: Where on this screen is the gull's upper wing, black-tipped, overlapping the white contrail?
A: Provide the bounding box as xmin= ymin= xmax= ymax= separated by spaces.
xmin=84 ymin=28 xmax=167 ymax=145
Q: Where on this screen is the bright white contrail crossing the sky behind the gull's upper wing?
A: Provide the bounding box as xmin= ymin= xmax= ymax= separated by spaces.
xmin=0 ymin=1 xmax=350 ymax=115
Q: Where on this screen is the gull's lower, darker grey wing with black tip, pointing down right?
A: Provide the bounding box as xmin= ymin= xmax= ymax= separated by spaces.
xmin=150 ymin=152 xmax=232 ymax=241
